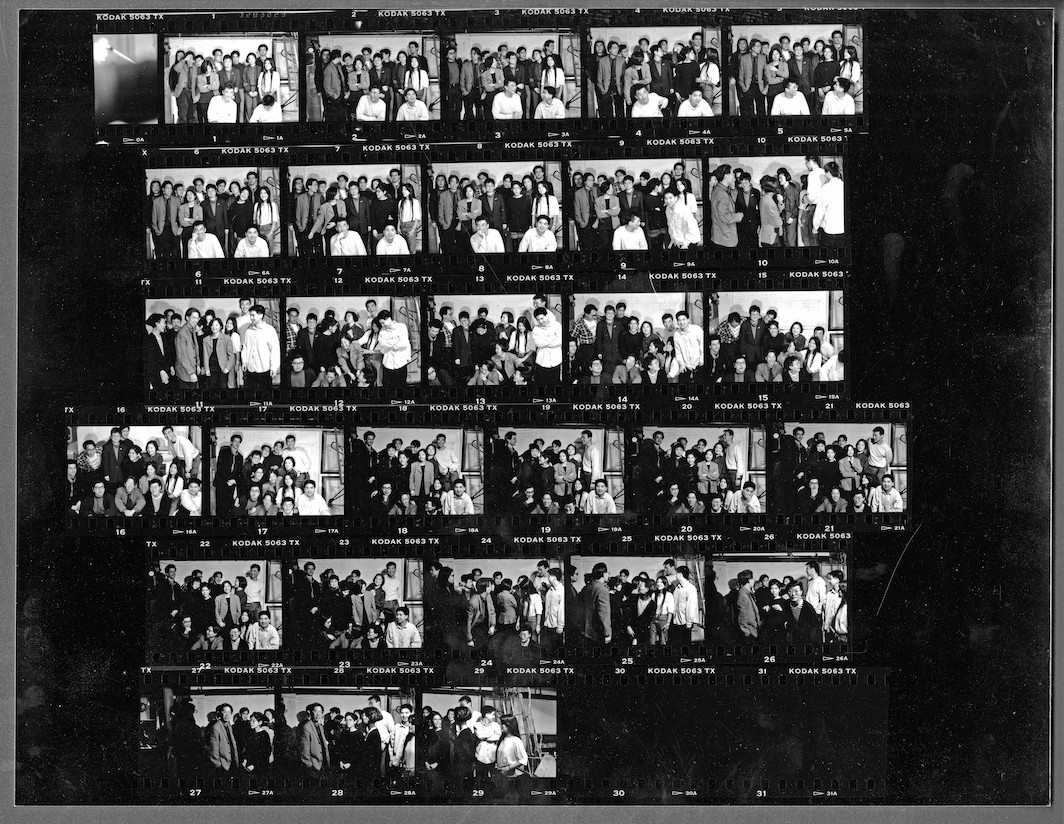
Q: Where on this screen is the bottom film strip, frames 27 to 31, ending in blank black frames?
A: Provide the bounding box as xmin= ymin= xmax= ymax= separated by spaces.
xmin=137 ymin=665 xmax=890 ymax=805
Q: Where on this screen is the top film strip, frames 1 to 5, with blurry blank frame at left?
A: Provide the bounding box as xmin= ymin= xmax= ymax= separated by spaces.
xmin=93 ymin=9 xmax=875 ymax=146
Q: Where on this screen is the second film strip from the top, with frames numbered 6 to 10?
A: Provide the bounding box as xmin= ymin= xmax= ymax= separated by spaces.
xmin=138 ymin=135 xmax=851 ymax=274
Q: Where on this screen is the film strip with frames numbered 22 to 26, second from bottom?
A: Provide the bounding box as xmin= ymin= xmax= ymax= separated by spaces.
xmin=143 ymin=535 xmax=860 ymax=672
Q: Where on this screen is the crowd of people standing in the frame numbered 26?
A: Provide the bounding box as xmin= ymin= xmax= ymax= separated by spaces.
xmin=723 ymin=559 xmax=848 ymax=646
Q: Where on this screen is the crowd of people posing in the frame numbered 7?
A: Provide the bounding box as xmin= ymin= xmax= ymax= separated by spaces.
xmin=287 ymin=168 xmax=422 ymax=258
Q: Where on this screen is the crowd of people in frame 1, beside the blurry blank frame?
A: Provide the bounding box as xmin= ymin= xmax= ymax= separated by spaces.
xmin=166 ymin=43 xmax=284 ymax=123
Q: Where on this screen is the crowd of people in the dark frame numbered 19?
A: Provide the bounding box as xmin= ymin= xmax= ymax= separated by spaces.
xmin=485 ymin=429 xmax=621 ymax=516
